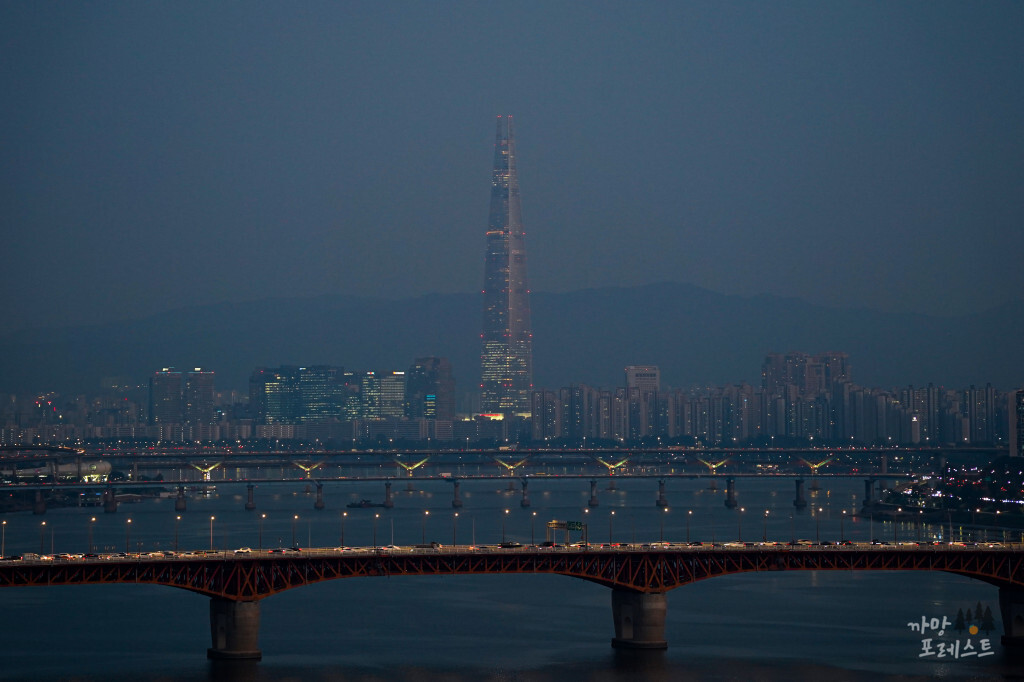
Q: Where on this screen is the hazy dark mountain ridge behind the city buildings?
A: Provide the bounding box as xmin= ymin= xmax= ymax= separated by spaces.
xmin=0 ymin=283 xmax=1024 ymax=393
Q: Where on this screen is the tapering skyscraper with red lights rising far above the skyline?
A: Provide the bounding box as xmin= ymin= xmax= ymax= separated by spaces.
xmin=480 ymin=116 xmax=534 ymax=416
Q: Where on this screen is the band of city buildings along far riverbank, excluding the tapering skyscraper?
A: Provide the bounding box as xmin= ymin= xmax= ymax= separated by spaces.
xmin=6 ymin=350 xmax=1024 ymax=453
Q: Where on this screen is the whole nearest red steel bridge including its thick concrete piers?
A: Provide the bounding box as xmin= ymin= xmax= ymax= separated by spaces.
xmin=0 ymin=543 xmax=1024 ymax=658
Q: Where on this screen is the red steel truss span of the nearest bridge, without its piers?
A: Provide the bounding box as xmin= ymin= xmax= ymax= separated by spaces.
xmin=0 ymin=547 xmax=1024 ymax=601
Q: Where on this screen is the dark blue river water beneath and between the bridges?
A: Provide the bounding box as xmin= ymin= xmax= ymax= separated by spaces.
xmin=0 ymin=477 xmax=1024 ymax=682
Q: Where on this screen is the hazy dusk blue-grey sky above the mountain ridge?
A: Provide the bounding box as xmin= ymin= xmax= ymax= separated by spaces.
xmin=0 ymin=0 xmax=1024 ymax=331
